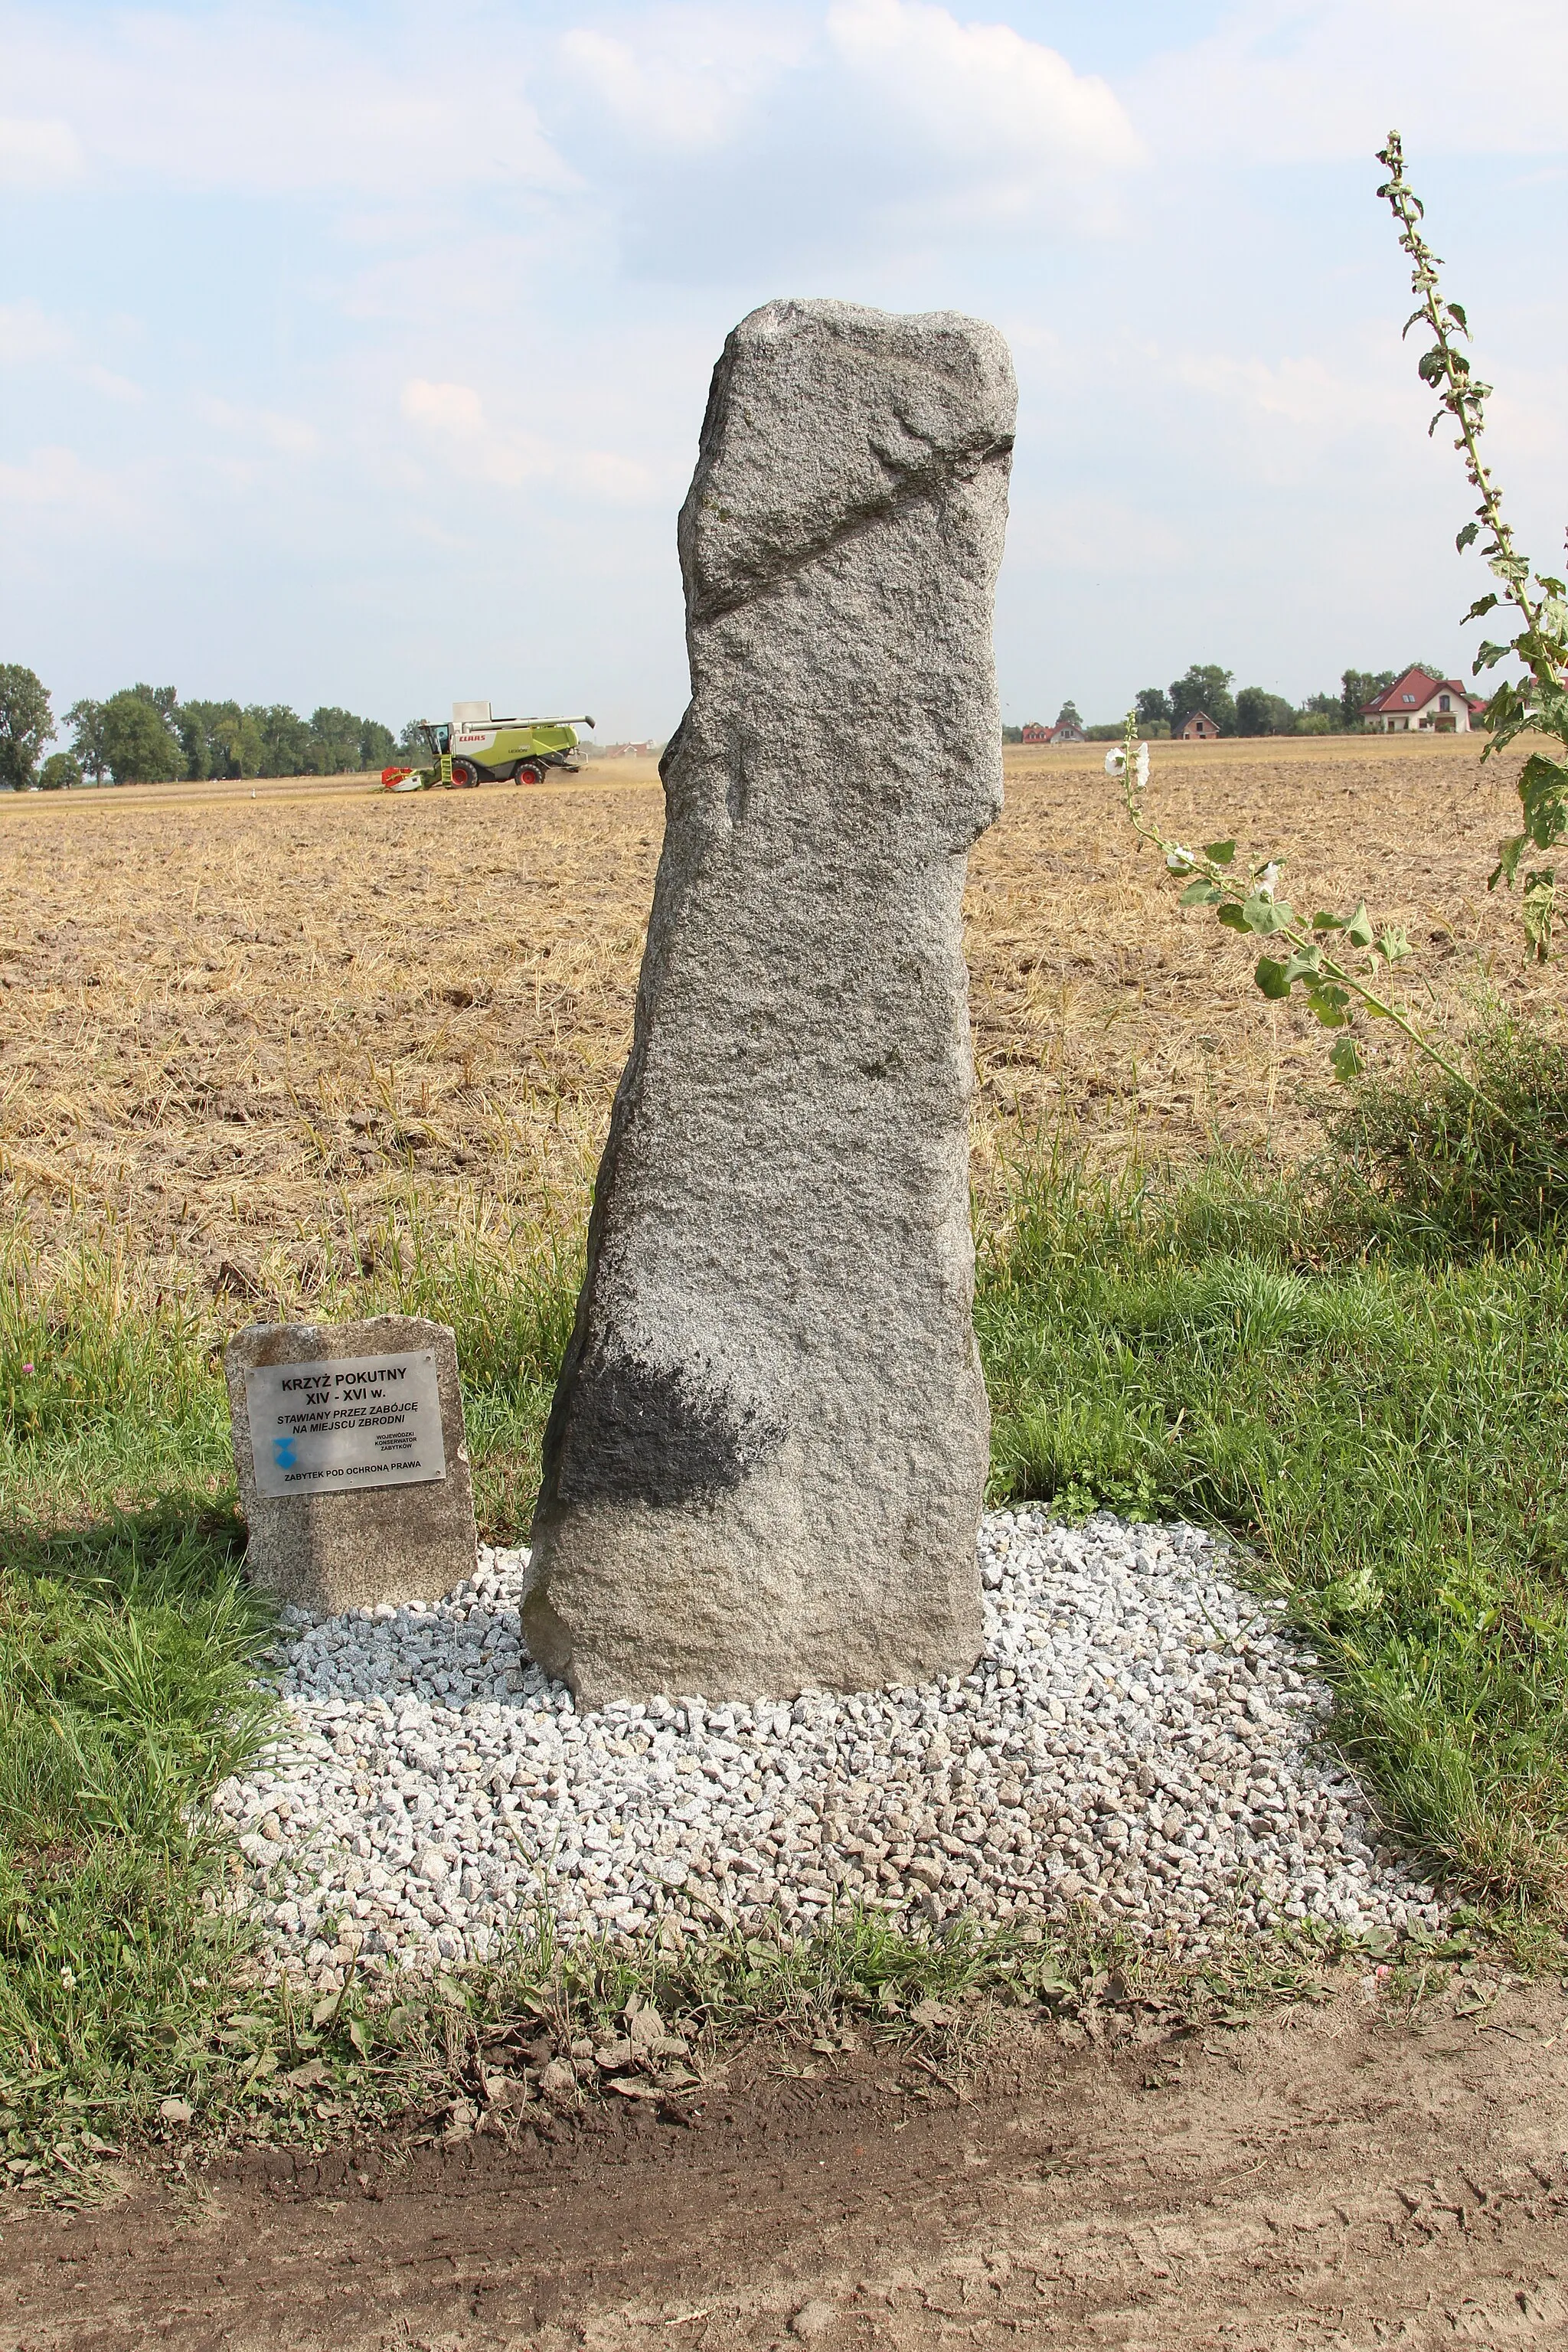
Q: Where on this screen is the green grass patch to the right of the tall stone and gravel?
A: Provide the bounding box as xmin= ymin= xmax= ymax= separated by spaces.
xmin=978 ymin=1165 xmax=1568 ymax=1917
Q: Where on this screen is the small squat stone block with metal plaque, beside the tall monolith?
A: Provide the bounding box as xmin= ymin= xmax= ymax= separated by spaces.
xmin=224 ymin=1315 xmax=477 ymax=1615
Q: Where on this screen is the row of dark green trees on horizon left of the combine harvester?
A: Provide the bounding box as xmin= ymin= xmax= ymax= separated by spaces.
xmin=0 ymin=661 xmax=397 ymax=792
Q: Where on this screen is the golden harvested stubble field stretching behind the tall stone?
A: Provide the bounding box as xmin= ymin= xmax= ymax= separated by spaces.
xmin=0 ymin=737 xmax=1566 ymax=1296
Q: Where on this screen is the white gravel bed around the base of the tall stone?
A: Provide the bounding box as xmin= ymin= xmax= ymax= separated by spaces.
xmin=214 ymin=1510 xmax=1441 ymax=1983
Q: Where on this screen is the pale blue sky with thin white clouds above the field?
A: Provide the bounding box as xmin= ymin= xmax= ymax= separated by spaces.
xmin=0 ymin=0 xmax=1568 ymax=739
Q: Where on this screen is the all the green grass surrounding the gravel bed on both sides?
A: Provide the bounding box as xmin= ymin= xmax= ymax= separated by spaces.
xmin=0 ymin=1037 xmax=1568 ymax=2174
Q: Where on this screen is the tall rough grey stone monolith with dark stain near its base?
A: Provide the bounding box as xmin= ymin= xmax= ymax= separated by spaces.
xmin=524 ymin=301 xmax=1015 ymax=1703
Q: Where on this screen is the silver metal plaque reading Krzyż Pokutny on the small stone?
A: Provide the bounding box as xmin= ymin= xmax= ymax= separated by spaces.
xmin=244 ymin=1348 xmax=446 ymax=1496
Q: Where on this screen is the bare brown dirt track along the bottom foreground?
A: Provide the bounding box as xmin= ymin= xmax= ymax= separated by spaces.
xmin=0 ymin=1985 xmax=1568 ymax=2352
